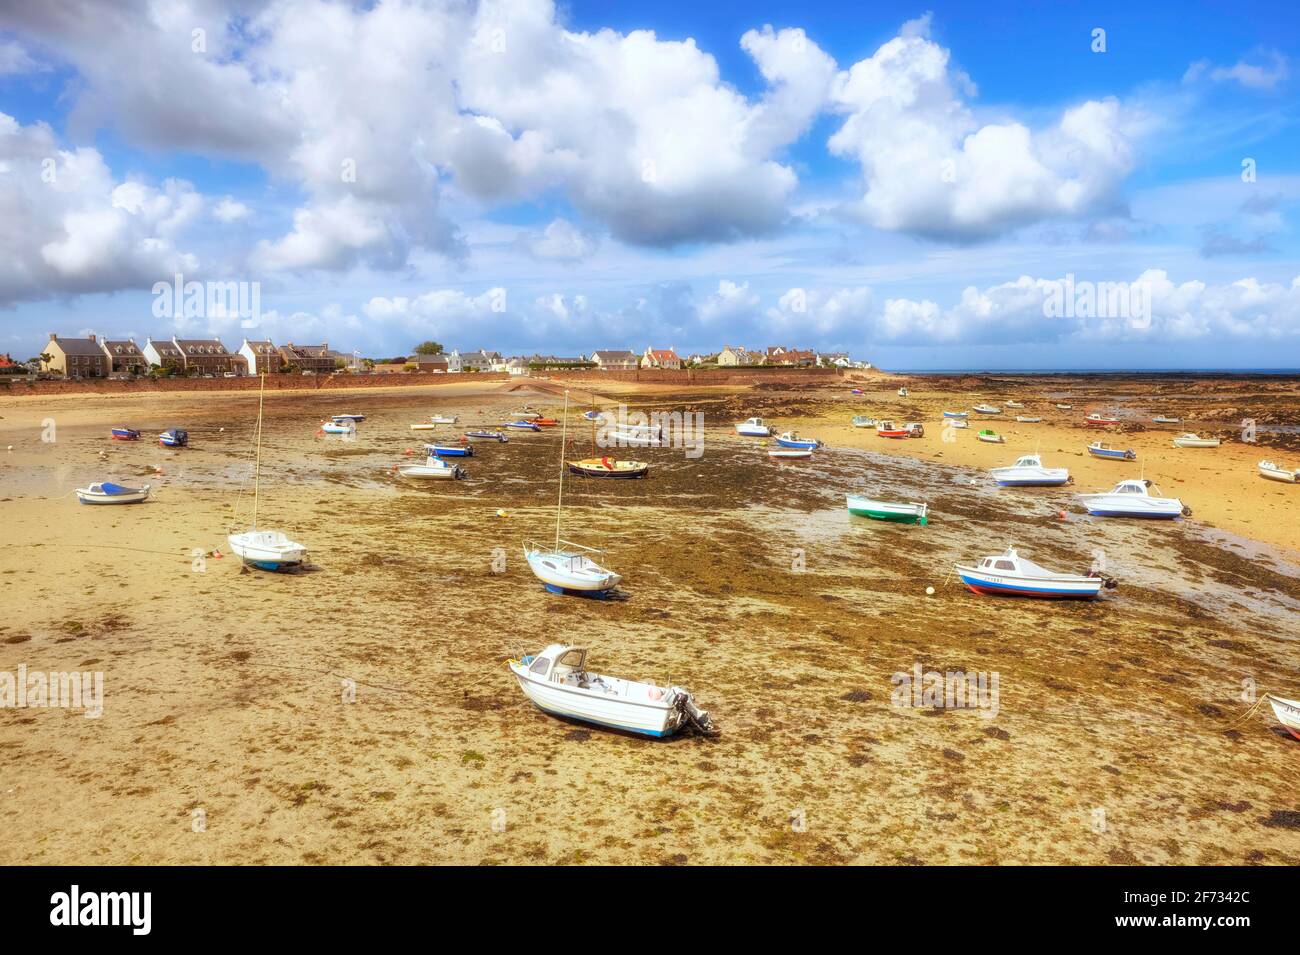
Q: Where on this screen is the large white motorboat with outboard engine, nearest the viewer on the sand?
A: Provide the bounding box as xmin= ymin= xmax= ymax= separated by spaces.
xmin=507 ymin=643 xmax=716 ymax=737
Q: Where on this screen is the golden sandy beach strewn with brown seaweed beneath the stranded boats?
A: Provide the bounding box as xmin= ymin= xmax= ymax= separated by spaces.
xmin=0 ymin=374 xmax=1300 ymax=865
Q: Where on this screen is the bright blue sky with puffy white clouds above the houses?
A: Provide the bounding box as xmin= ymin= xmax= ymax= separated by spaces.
xmin=0 ymin=0 xmax=1300 ymax=369
